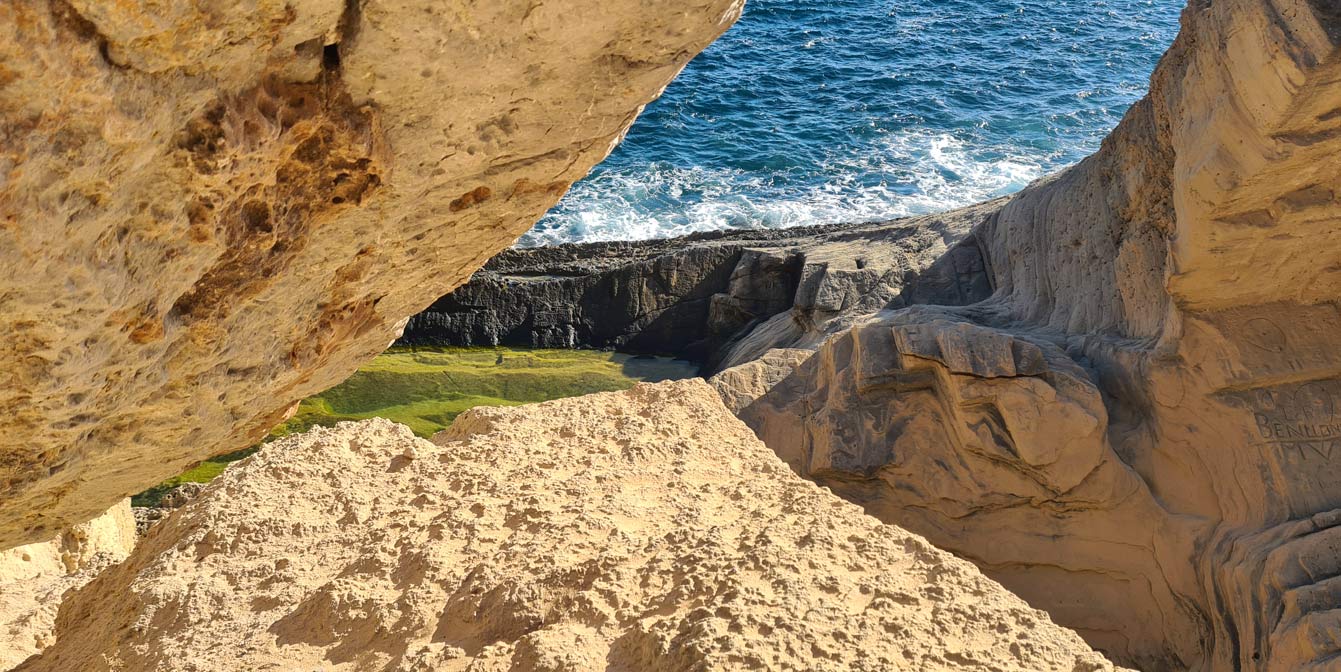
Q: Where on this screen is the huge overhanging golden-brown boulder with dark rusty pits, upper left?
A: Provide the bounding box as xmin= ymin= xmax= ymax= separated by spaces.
xmin=0 ymin=0 xmax=742 ymax=549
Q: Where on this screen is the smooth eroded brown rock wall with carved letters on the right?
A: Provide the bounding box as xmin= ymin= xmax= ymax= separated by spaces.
xmin=719 ymin=0 xmax=1341 ymax=671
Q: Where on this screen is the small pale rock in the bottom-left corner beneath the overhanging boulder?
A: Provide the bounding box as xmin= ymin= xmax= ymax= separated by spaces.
xmin=0 ymin=499 xmax=135 ymax=669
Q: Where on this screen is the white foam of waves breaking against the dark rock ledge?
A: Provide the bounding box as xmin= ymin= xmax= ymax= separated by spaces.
xmin=519 ymin=129 xmax=1055 ymax=247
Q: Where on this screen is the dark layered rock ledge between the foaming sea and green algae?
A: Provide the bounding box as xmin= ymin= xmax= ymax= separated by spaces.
xmin=401 ymin=204 xmax=999 ymax=370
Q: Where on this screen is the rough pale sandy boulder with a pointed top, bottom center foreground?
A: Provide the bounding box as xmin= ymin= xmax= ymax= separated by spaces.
xmin=19 ymin=381 xmax=1112 ymax=672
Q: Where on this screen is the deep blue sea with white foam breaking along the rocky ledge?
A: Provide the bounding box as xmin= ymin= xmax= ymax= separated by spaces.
xmin=520 ymin=0 xmax=1184 ymax=245
